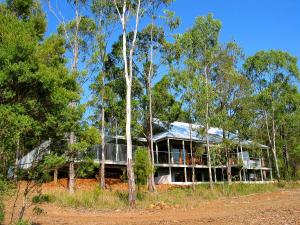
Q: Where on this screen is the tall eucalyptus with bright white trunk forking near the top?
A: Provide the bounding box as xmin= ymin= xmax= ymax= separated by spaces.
xmin=109 ymin=0 xmax=177 ymax=206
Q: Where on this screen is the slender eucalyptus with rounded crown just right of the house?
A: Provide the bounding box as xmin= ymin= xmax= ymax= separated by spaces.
xmin=244 ymin=50 xmax=300 ymax=179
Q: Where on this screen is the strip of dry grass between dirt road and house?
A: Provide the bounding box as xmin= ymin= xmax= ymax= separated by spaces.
xmin=45 ymin=182 xmax=300 ymax=209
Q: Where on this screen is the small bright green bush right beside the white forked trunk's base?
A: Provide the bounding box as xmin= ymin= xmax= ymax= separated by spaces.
xmin=134 ymin=148 xmax=154 ymax=185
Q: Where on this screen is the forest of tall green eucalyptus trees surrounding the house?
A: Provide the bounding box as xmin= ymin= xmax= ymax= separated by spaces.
xmin=0 ymin=0 xmax=300 ymax=223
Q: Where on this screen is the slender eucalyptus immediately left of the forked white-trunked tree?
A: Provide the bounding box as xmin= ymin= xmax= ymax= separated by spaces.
xmin=89 ymin=0 xmax=117 ymax=189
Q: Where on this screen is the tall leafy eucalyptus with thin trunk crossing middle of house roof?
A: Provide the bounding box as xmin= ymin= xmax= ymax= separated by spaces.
xmin=171 ymin=14 xmax=221 ymax=187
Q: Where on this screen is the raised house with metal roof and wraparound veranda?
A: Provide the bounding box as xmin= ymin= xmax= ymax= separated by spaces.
xmin=93 ymin=122 xmax=273 ymax=184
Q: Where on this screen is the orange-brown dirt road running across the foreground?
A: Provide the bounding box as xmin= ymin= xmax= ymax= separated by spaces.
xmin=4 ymin=190 xmax=300 ymax=225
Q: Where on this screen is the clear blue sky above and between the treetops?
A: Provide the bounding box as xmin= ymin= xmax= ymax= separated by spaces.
xmin=42 ymin=0 xmax=300 ymax=110
